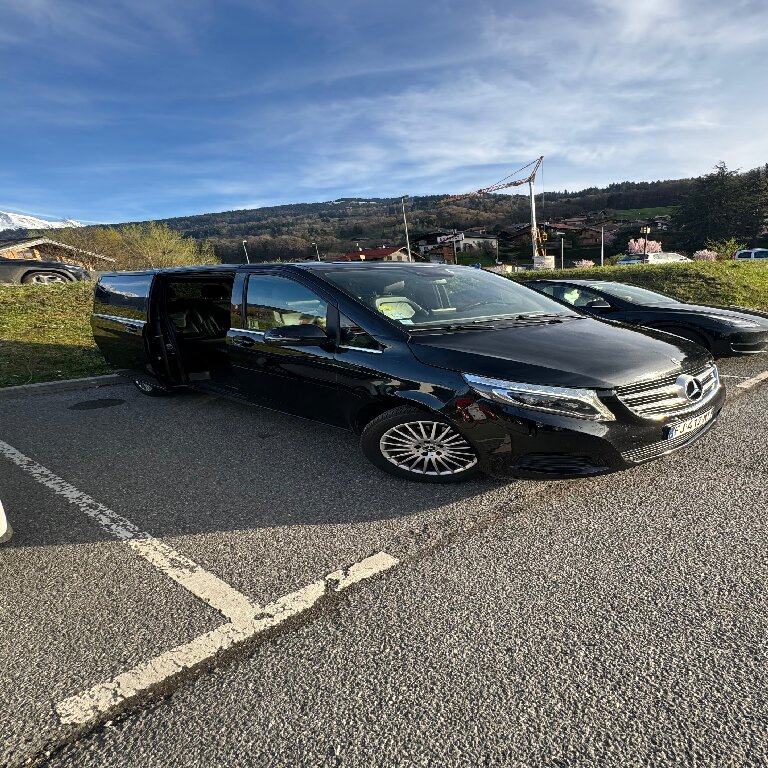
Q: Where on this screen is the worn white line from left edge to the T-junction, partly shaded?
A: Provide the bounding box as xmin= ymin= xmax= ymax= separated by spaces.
xmin=0 ymin=440 xmax=259 ymax=621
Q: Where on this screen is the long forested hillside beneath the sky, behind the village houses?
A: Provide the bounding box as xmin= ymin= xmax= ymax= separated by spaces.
xmin=14 ymin=163 xmax=768 ymax=262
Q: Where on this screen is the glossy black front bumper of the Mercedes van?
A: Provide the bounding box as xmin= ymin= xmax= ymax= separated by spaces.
xmin=452 ymin=386 xmax=725 ymax=480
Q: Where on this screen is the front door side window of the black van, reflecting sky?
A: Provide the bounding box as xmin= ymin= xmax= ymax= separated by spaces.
xmin=246 ymin=275 xmax=328 ymax=331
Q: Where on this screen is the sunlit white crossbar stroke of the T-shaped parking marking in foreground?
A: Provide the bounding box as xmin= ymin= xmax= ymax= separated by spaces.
xmin=56 ymin=552 xmax=399 ymax=726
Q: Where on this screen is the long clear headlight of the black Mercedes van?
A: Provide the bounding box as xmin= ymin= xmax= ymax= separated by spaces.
xmin=462 ymin=373 xmax=616 ymax=421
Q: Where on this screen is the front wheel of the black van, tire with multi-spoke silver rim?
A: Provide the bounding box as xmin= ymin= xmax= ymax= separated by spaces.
xmin=360 ymin=406 xmax=480 ymax=483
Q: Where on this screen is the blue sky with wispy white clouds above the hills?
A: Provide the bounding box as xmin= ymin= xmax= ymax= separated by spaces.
xmin=0 ymin=0 xmax=768 ymax=222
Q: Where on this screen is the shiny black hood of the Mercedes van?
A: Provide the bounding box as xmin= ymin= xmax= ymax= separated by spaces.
xmin=409 ymin=318 xmax=710 ymax=389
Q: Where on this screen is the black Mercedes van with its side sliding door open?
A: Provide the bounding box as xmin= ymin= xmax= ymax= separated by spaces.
xmin=92 ymin=262 xmax=725 ymax=483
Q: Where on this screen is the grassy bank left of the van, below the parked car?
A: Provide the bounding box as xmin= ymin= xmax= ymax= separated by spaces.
xmin=0 ymin=283 xmax=110 ymax=387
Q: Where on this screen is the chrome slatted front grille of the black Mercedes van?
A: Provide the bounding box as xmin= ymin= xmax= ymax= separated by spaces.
xmin=616 ymin=363 xmax=720 ymax=419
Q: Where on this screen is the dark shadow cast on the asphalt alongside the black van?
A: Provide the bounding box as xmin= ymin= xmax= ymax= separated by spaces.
xmin=0 ymin=386 xmax=503 ymax=546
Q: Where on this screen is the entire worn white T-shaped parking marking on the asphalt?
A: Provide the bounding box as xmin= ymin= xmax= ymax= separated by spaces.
xmin=0 ymin=440 xmax=399 ymax=726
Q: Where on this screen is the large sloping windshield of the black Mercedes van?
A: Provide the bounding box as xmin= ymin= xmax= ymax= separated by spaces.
xmin=320 ymin=264 xmax=573 ymax=328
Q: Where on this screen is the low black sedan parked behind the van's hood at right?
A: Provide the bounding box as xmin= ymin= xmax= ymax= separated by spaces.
xmin=526 ymin=280 xmax=768 ymax=356
